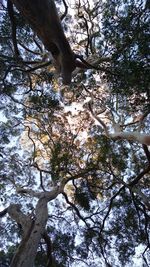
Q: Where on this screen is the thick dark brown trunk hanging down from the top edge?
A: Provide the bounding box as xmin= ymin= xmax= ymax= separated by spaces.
xmin=11 ymin=0 xmax=76 ymax=84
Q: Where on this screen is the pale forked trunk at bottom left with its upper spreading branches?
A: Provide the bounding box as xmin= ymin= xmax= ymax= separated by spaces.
xmin=8 ymin=187 xmax=61 ymax=267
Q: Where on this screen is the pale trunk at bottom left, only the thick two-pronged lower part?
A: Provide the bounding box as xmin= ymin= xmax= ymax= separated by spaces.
xmin=8 ymin=197 xmax=48 ymax=267
